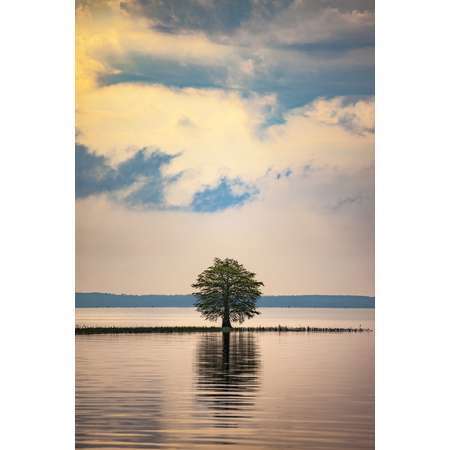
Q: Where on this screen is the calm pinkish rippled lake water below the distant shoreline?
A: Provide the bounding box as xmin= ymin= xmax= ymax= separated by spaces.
xmin=76 ymin=308 xmax=374 ymax=450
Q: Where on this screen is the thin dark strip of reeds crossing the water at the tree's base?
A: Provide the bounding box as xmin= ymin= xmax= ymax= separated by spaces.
xmin=75 ymin=325 xmax=372 ymax=334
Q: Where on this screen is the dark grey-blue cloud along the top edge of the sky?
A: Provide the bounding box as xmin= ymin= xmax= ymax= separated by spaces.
xmin=123 ymin=0 xmax=374 ymax=50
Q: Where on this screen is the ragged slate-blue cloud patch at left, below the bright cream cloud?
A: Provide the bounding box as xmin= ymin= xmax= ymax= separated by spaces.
xmin=75 ymin=144 xmax=258 ymax=213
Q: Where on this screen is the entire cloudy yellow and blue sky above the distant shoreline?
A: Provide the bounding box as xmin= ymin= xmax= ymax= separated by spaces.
xmin=75 ymin=0 xmax=374 ymax=295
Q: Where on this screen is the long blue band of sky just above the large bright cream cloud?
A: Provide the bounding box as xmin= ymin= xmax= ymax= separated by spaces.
xmin=99 ymin=53 xmax=375 ymax=112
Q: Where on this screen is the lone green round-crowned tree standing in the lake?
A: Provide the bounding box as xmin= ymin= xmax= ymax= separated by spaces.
xmin=192 ymin=258 xmax=264 ymax=328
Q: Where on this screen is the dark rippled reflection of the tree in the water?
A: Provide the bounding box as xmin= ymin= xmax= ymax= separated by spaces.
xmin=197 ymin=332 xmax=260 ymax=428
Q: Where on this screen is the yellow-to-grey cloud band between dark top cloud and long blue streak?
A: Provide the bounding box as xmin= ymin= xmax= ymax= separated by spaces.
xmin=76 ymin=0 xmax=373 ymax=94
